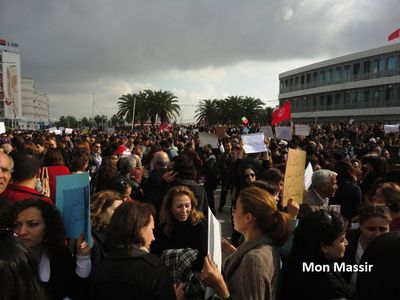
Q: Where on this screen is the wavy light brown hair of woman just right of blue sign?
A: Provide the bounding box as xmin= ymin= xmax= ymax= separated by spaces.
xmin=90 ymin=190 xmax=121 ymax=230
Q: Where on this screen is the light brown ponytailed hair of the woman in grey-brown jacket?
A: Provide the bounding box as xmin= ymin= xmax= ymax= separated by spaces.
xmin=238 ymin=186 xmax=290 ymax=246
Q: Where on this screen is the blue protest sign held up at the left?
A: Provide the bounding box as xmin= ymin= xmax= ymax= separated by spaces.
xmin=56 ymin=172 xmax=92 ymax=245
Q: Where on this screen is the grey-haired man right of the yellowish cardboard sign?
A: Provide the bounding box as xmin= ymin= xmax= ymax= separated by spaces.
xmin=299 ymin=169 xmax=338 ymax=217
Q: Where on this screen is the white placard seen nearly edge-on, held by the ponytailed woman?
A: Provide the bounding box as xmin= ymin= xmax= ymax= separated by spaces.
xmin=204 ymin=208 xmax=222 ymax=299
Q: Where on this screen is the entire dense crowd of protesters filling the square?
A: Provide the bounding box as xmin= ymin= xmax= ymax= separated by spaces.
xmin=0 ymin=122 xmax=400 ymax=300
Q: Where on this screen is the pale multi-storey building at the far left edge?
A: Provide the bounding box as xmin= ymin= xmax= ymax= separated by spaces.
xmin=0 ymin=38 xmax=50 ymax=129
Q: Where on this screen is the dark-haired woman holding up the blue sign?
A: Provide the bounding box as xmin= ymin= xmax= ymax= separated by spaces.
xmin=9 ymin=199 xmax=91 ymax=299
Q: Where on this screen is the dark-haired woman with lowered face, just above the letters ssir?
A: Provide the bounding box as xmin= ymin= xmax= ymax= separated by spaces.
xmin=342 ymin=202 xmax=392 ymax=288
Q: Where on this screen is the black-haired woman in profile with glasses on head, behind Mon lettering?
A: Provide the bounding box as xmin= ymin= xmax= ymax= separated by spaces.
xmin=281 ymin=210 xmax=353 ymax=300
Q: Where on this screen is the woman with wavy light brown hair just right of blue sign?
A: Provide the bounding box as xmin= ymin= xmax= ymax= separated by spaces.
xmin=90 ymin=190 xmax=123 ymax=263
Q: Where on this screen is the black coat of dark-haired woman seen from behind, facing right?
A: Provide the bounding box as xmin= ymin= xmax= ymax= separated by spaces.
xmin=90 ymin=248 xmax=175 ymax=300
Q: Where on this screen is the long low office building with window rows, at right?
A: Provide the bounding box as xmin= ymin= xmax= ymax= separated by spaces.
xmin=279 ymin=43 xmax=400 ymax=122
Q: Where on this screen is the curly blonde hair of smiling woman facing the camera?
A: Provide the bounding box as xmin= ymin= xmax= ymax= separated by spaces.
xmin=160 ymin=186 xmax=204 ymax=237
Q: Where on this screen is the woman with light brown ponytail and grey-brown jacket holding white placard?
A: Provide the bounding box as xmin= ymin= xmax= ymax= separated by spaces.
xmin=202 ymin=186 xmax=290 ymax=299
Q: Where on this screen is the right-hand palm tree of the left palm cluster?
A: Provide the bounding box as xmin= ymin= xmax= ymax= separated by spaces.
xmin=144 ymin=90 xmax=181 ymax=124
